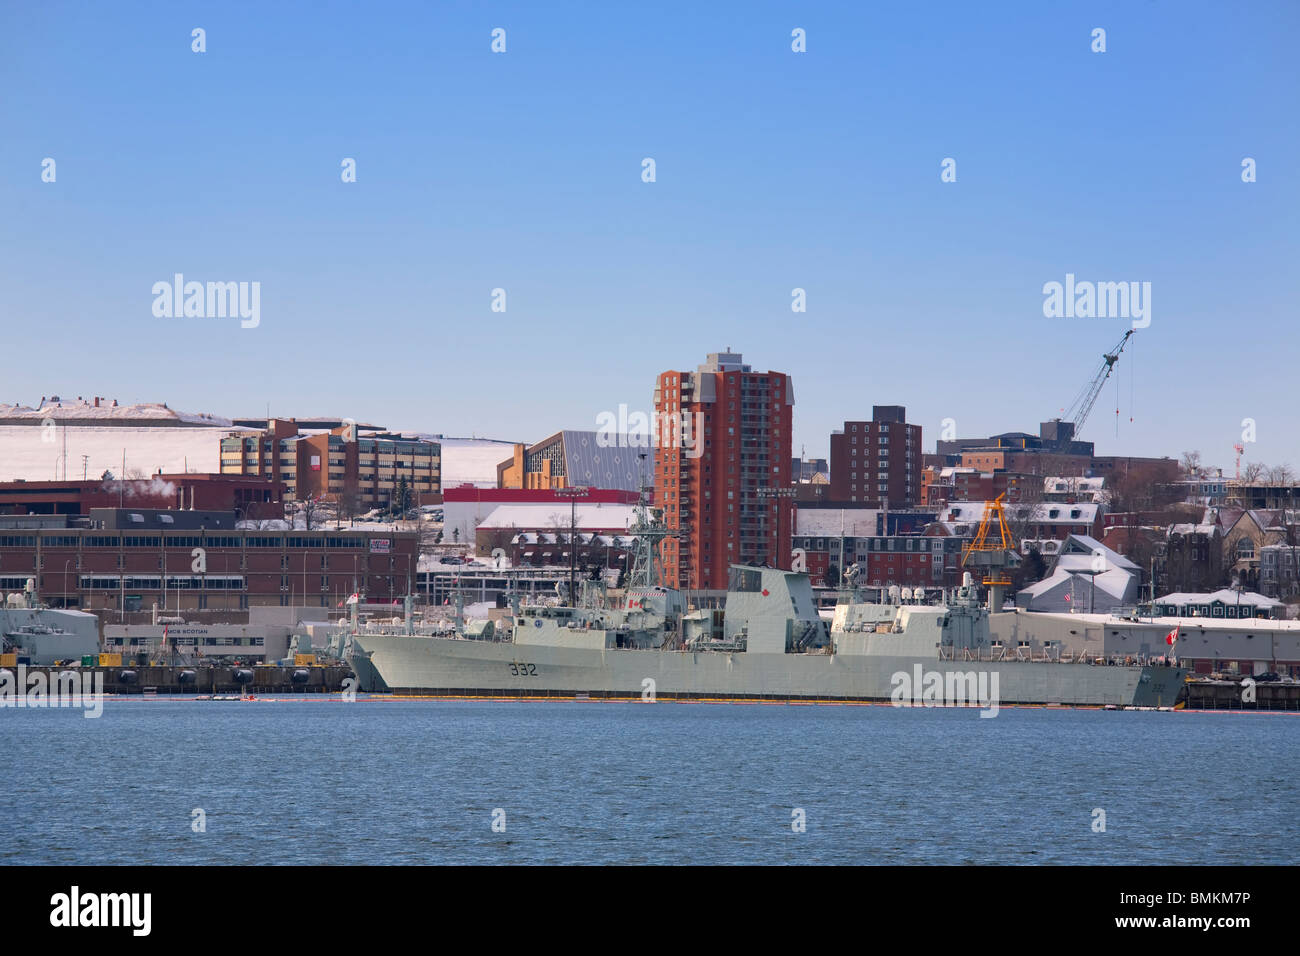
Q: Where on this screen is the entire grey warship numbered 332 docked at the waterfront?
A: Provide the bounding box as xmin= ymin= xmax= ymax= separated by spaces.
xmin=345 ymin=507 xmax=1187 ymax=711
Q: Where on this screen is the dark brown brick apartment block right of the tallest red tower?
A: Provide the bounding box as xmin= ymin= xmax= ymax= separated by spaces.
xmin=831 ymin=405 xmax=922 ymax=509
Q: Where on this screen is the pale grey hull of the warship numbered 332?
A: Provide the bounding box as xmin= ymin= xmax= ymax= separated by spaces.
xmin=351 ymin=635 xmax=1186 ymax=706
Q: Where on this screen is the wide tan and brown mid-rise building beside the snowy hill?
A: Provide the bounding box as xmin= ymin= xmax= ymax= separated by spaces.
xmin=221 ymin=419 xmax=442 ymax=511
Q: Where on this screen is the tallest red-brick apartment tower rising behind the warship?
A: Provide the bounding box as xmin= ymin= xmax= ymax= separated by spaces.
xmin=654 ymin=352 xmax=790 ymax=589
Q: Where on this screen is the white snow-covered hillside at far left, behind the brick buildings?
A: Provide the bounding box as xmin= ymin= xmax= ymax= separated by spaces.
xmin=0 ymin=424 xmax=230 ymax=481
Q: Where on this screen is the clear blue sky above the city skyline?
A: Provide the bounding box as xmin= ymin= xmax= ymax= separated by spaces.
xmin=0 ymin=0 xmax=1300 ymax=467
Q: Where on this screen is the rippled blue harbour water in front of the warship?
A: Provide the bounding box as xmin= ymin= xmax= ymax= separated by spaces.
xmin=0 ymin=698 xmax=1300 ymax=864
